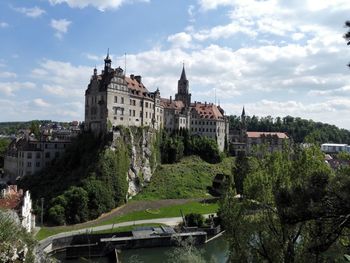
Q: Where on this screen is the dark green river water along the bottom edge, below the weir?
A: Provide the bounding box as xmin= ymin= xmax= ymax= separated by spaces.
xmin=57 ymin=237 xmax=228 ymax=263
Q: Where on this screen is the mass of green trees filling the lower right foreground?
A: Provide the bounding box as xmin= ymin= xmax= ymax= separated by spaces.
xmin=219 ymin=147 xmax=350 ymax=263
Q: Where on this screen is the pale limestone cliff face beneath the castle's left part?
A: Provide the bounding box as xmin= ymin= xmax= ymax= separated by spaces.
xmin=113 ymin=127 xmax=157 ymax=198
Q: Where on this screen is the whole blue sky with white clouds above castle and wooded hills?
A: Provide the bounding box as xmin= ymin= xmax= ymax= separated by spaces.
xmin=0 ymin=0 xmax=350 ymax=129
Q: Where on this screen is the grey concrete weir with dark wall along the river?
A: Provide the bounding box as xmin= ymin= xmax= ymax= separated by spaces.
xmin=42 ymin=226 xmax=212 ymax=262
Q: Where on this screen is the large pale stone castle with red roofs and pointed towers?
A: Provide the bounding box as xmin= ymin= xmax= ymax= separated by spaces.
xmin=84 ymin=54 xmax=229 ymax=151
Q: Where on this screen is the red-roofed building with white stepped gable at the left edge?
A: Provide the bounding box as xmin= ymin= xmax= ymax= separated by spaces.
xmin=0 ymin=185 xmax=35 ymax=232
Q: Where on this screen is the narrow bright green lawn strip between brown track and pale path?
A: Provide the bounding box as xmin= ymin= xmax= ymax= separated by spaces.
xmin=35 ymin=202 xmax=218 ymax=240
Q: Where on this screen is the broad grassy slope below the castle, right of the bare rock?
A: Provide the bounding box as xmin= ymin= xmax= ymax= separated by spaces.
xmin=134 ymin=156 xmax=233 ymax=200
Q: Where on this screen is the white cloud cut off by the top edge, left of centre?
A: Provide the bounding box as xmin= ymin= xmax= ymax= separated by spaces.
xmin=49 ymin=0 xmax=149 ymax=11
